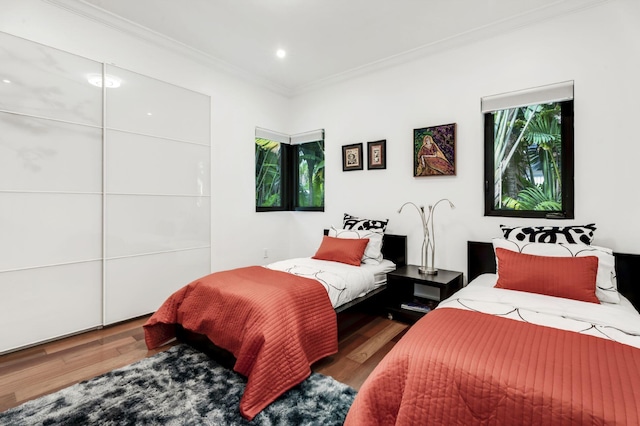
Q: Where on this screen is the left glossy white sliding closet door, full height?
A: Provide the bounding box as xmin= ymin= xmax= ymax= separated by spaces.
xmin=0 ymin=33 xmax=102 ymax=353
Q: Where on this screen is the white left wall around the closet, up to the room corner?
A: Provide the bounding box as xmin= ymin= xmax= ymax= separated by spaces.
xmin=0 ymin=0 xmax=290 ymax=270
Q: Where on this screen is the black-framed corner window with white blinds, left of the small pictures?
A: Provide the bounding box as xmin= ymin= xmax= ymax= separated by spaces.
xmin=255 ymin=128 xmax=324 ymax=211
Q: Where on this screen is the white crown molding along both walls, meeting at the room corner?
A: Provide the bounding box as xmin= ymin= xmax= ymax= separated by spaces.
xmin=42 ymin=0 xmax=614 ymax=97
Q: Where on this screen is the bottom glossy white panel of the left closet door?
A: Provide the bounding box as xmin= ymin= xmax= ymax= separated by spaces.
xmin=0 ymin=261 xmax=102 ymax=353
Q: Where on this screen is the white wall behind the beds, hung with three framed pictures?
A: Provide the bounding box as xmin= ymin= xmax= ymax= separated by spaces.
xmin=292 ymin=0 xmax=640 ymax=271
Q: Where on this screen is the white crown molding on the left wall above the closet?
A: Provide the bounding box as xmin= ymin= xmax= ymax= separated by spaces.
xmin=42 ymin=0 xmax=292 ymax=97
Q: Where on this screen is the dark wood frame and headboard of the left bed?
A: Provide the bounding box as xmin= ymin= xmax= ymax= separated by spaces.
xmin=176 ymin=233 xmax=407 ymax=370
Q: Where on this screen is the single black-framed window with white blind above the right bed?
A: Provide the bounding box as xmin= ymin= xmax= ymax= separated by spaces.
xmin=482 ymin=82 xmax=574 ymax=219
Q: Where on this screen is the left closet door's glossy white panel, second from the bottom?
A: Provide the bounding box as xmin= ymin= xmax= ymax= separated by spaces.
xmin=0 ymin=193 xmax=102 ymax=270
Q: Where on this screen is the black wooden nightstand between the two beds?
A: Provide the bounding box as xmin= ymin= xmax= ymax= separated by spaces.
xmin=387 ymin=265 xmax=462 ymax=323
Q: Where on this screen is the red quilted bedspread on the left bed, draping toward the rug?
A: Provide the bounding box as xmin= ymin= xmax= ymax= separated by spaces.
xmin=144 ymin=266 xmax=338 ymax=420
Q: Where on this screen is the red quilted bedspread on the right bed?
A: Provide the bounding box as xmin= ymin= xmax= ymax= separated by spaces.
xmin=345 ymin=308 xmax=640 ymax=426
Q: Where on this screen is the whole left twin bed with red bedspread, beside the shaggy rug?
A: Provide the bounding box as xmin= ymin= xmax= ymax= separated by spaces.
xmin=144 ymin=220 xmax=406 ymax=420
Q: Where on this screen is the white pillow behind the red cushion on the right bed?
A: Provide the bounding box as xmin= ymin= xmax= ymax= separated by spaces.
xmin=492 ymin=238 xmax=620 ymax=303
